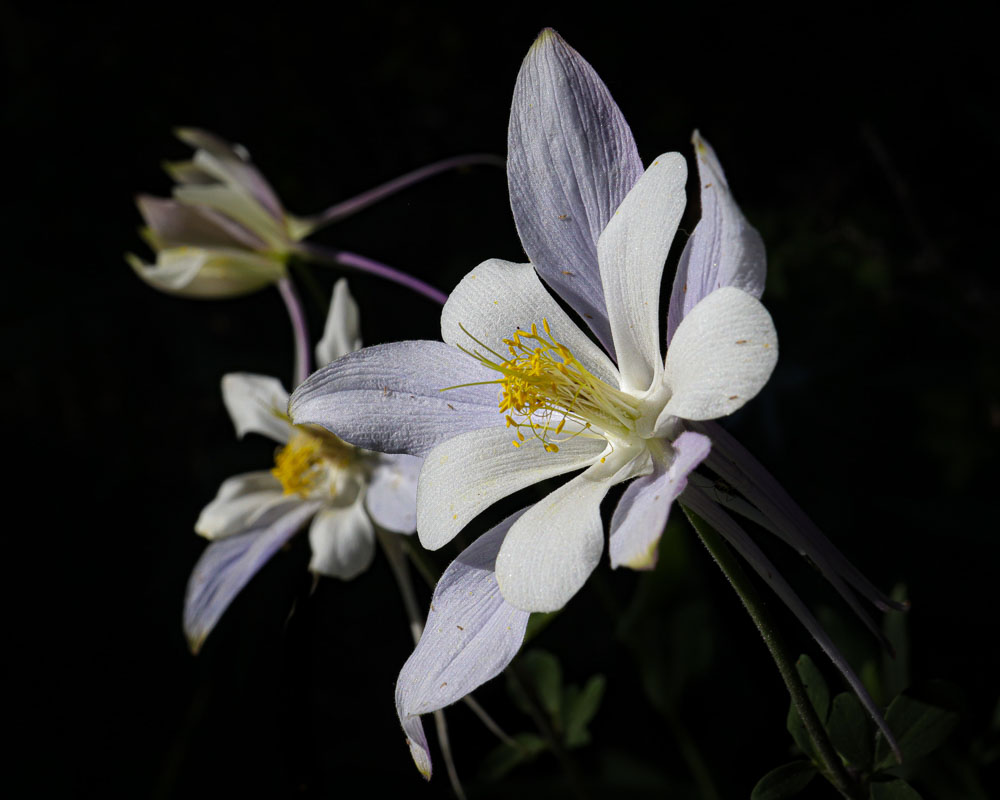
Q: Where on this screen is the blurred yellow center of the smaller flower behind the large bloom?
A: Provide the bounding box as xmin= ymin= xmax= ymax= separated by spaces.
xmin=271 ymin=426 xmax=357 ymax=497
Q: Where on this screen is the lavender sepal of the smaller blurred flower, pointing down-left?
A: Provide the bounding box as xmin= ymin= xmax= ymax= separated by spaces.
xmin=184 ymin=502 xmax=321 ymax=653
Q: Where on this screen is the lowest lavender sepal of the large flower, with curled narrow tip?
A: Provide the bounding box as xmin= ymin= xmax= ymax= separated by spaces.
xmin=396 ymin=509 xmax=530 ymax=777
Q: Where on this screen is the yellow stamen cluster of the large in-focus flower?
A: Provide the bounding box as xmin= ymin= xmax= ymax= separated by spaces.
xmin=452 ymin=319 xmax=639 ymax=453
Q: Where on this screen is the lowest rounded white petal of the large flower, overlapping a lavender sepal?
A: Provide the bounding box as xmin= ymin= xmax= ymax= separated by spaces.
xmin=496 ymin=470 xmax=612 ymax=612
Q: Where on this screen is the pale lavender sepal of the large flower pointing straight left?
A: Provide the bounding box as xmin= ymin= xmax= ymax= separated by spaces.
xmin=288 ymin=341 xmax=504 ymax=456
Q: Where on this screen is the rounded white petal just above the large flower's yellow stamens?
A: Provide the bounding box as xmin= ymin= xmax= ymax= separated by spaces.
xmin=441 ymin=258 xmax=618 ymax=388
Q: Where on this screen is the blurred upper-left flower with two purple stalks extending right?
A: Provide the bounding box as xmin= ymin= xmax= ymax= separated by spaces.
xmin=126 ymin=128 xmax=503 ymax=302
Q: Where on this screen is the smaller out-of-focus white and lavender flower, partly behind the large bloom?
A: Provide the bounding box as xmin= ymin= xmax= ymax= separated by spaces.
xmin=184 ymin=280 xmax=420 ymax=652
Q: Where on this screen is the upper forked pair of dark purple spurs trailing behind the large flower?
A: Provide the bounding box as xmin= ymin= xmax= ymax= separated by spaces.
xmin=686 ymin=422 xmax=906 ymax=624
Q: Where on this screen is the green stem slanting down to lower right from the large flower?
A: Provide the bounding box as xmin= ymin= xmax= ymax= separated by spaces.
xmin=684 ymin=508 xmax=861 ymax=800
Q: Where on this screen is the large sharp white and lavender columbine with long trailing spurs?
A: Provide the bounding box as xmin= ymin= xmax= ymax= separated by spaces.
xmin=290 ymin=31 xmax=900 ymax=774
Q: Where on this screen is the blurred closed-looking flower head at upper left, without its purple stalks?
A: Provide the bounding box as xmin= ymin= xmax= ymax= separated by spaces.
xmin=127 ymin=128 xmax=313 ymax=297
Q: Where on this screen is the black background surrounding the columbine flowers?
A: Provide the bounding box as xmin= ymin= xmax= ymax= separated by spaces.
xmin=0 ymin=3 xmax=1000 ymax=798
